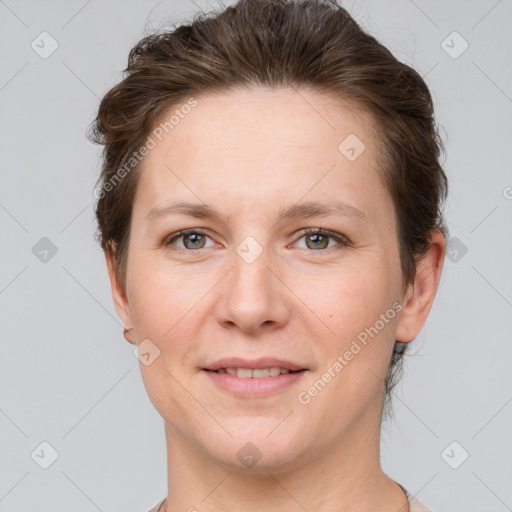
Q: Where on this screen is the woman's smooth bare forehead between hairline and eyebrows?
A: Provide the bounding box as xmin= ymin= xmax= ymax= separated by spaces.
xmin=132 ymin=89 xmax=388 ymax=222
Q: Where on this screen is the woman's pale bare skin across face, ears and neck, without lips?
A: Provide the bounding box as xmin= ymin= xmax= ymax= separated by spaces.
xmin=107 ymin=89 xmax=445 ymax=512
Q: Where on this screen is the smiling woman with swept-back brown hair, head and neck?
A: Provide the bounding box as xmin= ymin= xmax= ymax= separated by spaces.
xmin=92 ymin=0 xmax=446 ymax=512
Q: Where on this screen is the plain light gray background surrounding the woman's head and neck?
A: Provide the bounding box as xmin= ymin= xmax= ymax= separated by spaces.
xmin=0 ymin=0 xmax=512 ymax=512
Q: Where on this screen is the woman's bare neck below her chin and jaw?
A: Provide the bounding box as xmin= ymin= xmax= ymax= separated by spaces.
xmin=162 ymin=402 xmax=409 ymax=512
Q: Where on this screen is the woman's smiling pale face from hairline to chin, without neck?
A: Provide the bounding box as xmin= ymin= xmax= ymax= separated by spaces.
xmin=111 ymin=89 xmax=426 ymax=468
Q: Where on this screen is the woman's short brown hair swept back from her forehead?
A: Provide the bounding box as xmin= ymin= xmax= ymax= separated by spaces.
xmin=89 ymin=0 xmax=447 ymax=416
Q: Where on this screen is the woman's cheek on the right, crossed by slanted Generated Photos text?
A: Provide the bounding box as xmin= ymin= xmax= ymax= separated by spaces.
xmin=297 ymin=260 xmax=398 ymax=396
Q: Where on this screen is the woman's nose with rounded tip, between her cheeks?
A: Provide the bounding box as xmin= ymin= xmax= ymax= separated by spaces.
xmin=216 ymin=243 xmax=291 ymax=333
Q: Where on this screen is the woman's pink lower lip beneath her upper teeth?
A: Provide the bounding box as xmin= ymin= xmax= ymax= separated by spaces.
xmin=202 ymin=370 xmax=307 ymax=397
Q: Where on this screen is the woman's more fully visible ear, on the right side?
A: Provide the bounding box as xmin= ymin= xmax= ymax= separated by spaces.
xmin=395 ymin=229 xmax=446 ymax=343
